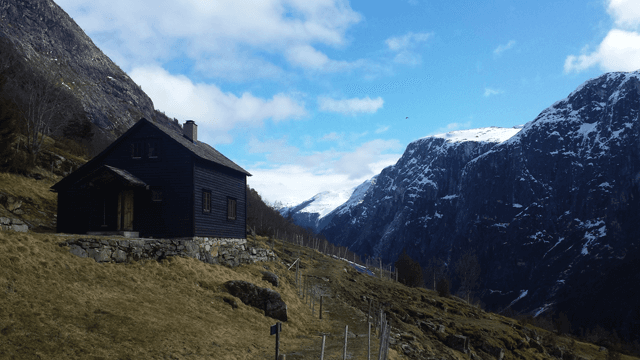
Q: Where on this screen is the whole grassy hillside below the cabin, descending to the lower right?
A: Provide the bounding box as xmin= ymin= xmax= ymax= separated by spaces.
xmin=0 ymin=231 xmax=630 ymax=359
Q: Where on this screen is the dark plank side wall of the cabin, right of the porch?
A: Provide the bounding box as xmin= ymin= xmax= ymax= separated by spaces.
xmin=193 ymin=161 xmax=247 ymax=239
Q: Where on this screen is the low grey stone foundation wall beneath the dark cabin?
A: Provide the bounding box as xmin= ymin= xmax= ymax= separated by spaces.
xmin=60 ymin=237 xmax=276 ymax=267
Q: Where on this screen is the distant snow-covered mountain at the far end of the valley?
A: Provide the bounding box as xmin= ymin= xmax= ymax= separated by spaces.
xmin=279 ymin=177 xmax=376 ymax=233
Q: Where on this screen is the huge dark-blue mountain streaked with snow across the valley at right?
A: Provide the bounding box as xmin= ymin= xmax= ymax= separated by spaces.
xmin=323 ymin=72 xmax=640 ymax=339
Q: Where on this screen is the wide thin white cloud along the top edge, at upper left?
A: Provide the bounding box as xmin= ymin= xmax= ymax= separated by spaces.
xmin=58 ymin=0 xmax=362 ymax=74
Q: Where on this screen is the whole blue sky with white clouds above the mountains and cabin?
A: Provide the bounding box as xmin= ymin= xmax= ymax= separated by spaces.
xmin=57 ymin=0 xmax=640 ymax=204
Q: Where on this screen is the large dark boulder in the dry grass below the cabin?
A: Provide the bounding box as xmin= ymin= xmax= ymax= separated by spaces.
xmin=224 ymin=280 xmax=287 ymax=321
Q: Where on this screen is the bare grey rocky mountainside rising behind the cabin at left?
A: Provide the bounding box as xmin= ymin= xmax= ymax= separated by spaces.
xmin=0 ymin=0 xmax=176 ymax=151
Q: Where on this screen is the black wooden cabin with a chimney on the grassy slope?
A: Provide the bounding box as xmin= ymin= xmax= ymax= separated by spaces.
xmin=51 ymin=119 xmax=251 ymax=238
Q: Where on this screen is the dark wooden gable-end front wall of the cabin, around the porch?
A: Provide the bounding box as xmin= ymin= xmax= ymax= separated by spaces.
xmin=58 ymin=125 xmax=193 ymax=237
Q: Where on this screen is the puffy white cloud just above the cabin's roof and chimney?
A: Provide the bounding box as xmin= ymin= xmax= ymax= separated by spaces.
xmin=130 ymin=66 xmax=306 ymax=143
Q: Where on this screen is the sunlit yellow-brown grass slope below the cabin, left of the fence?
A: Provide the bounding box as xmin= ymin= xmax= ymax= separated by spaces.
xmin=0 ymin=232 xmax=338 ymax=359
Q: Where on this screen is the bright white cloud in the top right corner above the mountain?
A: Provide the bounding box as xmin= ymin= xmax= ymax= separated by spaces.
xmin=564 ymin=0 xmax=640 ymax=73
